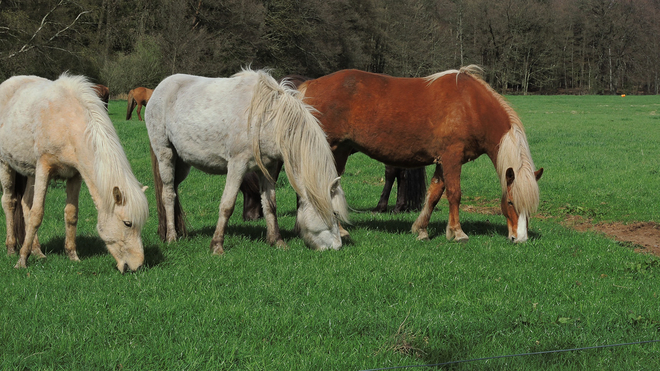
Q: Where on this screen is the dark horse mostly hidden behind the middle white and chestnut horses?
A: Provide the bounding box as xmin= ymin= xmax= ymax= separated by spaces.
xmin=240 ymin=75 xmax=426 ymax=221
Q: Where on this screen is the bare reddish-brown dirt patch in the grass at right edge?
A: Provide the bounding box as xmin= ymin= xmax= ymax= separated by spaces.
xmin=562 ymin=215 xmax=660 ymax=256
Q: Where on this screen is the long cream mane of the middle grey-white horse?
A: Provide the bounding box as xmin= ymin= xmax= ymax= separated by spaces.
xmin=244 ymin=70 xmax=348 ymax=225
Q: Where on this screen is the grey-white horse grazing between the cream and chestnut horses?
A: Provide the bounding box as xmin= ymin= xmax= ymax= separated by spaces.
xmin=145 ymin=70 xmax=348 ymax=254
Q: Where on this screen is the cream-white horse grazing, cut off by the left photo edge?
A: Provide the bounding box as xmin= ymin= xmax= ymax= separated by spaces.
xmin=0 ymin=74 xmax=149 ymax=273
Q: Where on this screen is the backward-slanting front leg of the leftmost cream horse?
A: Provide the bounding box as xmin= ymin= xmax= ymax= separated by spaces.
xmin=14 ymin=161 xmax=49 ymax=268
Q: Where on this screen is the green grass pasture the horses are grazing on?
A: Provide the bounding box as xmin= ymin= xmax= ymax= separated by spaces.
xmin=0 ymin=96 xmax=660 ymax=370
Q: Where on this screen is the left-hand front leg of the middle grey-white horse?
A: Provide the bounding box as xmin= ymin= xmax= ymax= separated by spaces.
xmin=210 ymin=163 xmax=245 ymax=255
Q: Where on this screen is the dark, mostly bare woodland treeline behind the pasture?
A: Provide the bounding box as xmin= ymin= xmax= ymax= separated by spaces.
xmin=0 ymin=0 xmax=660 ymax=94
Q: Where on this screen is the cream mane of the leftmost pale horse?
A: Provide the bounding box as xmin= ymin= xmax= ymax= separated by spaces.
xmin=56 ymin=74 xmax=149 ymax=228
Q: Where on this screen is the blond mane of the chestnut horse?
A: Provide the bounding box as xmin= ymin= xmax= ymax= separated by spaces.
xmin=426 ymin=65 xmax=539 ymax=216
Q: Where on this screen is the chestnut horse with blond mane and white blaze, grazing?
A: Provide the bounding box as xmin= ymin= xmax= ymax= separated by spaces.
xmin=299 ymin=66 xmax=543 ymax=242
